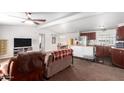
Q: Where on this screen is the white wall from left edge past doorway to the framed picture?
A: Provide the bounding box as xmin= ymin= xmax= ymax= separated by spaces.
xmin=0 ymin=26 xmax=58 ymax=59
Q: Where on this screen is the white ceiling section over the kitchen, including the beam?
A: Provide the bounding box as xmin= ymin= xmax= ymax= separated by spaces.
xmin=41 ymin=12 xmax=124 ymax=33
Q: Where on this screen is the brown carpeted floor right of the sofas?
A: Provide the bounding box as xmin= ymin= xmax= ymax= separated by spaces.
xmin=49 ymin=58 xmax=124 ymax=81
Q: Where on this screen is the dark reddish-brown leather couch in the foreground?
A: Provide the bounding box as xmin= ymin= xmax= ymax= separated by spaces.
xmin=7 ymin=52 xmax=45 ymax=81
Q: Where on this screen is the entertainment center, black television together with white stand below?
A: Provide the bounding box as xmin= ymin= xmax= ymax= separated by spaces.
xmin=14 ymin=38 xmax=32 ymax=56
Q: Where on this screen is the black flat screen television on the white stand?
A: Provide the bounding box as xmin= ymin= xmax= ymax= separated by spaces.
xmin=14 ymin=38 xmax=32 ymax=47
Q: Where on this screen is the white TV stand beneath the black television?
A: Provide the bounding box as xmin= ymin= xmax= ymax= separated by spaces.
xmin=14 ymin=46 xmax=32 ymax=56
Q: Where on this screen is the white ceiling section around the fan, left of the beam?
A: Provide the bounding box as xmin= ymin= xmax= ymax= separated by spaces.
xmin=0 ymin=12 xmax=76 ymax=25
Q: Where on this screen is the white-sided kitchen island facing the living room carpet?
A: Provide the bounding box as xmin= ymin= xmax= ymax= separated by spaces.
xmin=71 ymin=45 xmax=95 ymax=60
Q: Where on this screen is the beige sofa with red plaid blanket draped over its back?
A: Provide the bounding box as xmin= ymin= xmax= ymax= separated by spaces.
xmin=45 ymin=49 xmax=73 ymax=78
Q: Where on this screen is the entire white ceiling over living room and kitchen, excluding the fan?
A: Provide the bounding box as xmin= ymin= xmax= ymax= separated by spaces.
xmin=0 ymin=12 xmax=124 ymax=33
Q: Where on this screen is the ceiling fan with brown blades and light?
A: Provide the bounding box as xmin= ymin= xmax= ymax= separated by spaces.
xmin=9 ymin=12 xmax=46 ymax=25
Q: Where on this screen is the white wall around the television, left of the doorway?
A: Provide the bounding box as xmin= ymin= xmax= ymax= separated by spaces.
xmin=0 ymin=26 xmax=39 ymax=59
